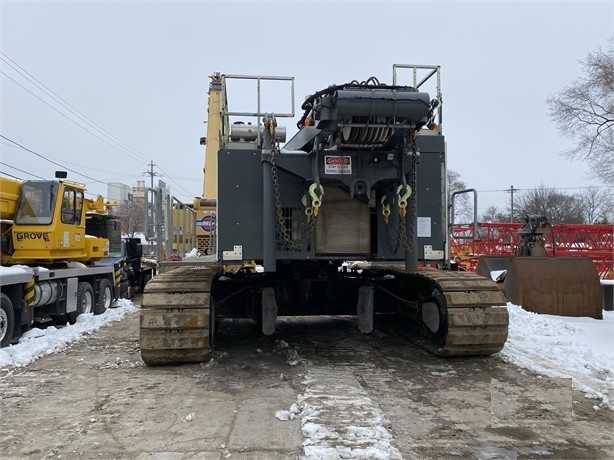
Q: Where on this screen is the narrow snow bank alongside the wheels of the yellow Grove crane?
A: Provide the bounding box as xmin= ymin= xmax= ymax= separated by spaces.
xmin=0 ymin=299 xmax=137 ymax=368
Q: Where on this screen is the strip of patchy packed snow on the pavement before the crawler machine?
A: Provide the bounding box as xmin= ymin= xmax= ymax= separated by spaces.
xmin=275 ymin=368 xmax=402 ymax=460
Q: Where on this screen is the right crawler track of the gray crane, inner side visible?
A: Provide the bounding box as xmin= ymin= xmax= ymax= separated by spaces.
xmin=369 ymin=266 xmax=509 ymax=356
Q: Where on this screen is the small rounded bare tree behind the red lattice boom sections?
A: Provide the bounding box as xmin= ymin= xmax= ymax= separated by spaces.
xmin=518 ymin=184 xmax=584 ymax=224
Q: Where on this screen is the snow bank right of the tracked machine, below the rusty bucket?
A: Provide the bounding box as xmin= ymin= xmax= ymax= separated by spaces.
xmin=500 ymin=303 xmax=614 ymax=409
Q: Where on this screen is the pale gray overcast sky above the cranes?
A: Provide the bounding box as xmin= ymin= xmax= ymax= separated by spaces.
xmin=0 ymin=0 xmax=614 ymax=213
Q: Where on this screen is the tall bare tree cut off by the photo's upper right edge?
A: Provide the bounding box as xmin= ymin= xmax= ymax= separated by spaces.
xmin=547 ymin=38 xmax=614 ymax=184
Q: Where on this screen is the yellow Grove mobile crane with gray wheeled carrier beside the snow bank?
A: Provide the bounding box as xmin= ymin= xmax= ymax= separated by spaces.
xmin=0 ymin=173 xmax=123 ymax=347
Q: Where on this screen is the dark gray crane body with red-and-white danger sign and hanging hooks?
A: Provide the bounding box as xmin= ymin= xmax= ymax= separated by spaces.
xmin=217 ymin=80 xmax=447 ymax=271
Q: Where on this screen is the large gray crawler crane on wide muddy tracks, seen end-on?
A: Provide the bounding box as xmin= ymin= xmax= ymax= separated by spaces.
xmin=140 ymin=65 xmax=508 ymax=365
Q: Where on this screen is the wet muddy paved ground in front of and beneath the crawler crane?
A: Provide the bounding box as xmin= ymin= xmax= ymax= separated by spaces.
xmin=0 ymin=312 xmax=614 ymax=460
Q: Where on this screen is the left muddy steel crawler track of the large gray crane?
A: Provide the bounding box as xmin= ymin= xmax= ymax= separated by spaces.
xmin=140 ymin=266 xmax=220 ymax=365
